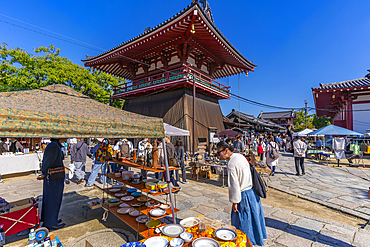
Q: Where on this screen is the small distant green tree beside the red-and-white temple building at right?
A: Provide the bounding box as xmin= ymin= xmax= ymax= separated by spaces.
xmin=293 ymin=110 xmax=333 ymax=131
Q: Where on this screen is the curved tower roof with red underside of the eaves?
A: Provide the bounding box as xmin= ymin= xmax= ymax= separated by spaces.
xmin=82 ymin=1 xmax=257 ymax=79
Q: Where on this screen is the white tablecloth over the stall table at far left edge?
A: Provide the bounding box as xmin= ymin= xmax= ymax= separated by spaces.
xmin=0 ymin=153 xmax=43 ymax=175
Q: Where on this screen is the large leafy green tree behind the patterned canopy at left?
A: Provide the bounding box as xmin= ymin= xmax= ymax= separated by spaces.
xmin=0 ymin=43 xmax=126 ymax=108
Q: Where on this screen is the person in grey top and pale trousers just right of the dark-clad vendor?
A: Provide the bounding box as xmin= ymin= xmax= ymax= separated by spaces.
xmin=71 ymin=138 xmax=92 ymax=184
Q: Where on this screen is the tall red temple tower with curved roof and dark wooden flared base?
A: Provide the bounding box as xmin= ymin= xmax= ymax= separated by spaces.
xmin=83 ymin=0 xmax=256 ymax=150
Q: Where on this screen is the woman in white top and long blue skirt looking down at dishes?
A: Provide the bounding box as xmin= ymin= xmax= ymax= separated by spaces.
xmin=217 ymin=141 xmax=267 ymax=246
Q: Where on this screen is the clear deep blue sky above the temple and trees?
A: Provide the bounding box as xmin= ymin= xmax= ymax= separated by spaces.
xmin=0 ymin=0 xmax=370 ymax=115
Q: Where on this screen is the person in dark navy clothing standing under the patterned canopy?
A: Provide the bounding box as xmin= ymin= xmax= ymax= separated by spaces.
xmin=37 ymin=139 xmax=65 ymax=229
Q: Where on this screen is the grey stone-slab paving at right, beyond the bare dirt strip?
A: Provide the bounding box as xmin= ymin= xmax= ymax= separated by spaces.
xmin=266 ymin=153 xmax=370 ymax=221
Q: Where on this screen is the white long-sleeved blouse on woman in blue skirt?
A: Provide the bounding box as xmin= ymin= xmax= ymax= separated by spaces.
xmin=227 ymin=153 xmax=253 ymax=203
